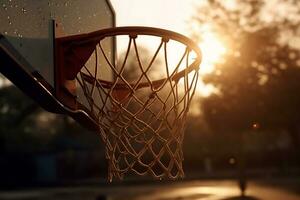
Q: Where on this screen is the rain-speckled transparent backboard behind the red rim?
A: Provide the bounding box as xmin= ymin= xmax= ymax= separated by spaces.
xmin=0 ymin=0 xmax=115 ymax=130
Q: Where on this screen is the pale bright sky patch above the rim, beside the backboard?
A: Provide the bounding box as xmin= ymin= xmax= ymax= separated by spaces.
xmin=111 ymin=0 xmax=199 ymax=34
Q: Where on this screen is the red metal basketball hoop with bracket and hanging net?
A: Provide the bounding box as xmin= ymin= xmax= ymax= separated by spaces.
xmin=56 ymin=27 xmax=201 ymax=181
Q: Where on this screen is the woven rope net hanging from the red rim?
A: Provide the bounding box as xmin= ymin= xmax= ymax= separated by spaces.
xmin=67 ymin=29 xmax=199 ymax=181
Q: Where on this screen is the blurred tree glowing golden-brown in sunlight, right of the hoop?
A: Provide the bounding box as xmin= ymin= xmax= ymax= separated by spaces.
xmin=193 ymin=0 xmax=300 ymax=152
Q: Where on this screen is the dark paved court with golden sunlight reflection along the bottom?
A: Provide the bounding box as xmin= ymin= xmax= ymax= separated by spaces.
xmin=0 ymin=180 xmax=300 ymax=200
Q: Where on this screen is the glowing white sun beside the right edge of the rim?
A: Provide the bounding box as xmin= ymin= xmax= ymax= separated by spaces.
xmin=199 ymin=32 xmax=226 ymax=74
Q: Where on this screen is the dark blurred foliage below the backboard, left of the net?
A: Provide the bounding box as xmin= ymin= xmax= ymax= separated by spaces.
xmin=0 ymin=80 xmax=100 ymax=153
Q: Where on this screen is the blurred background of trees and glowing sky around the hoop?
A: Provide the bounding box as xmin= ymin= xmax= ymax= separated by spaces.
xmin=0 ymin=0 xmax=300 ymax=199
